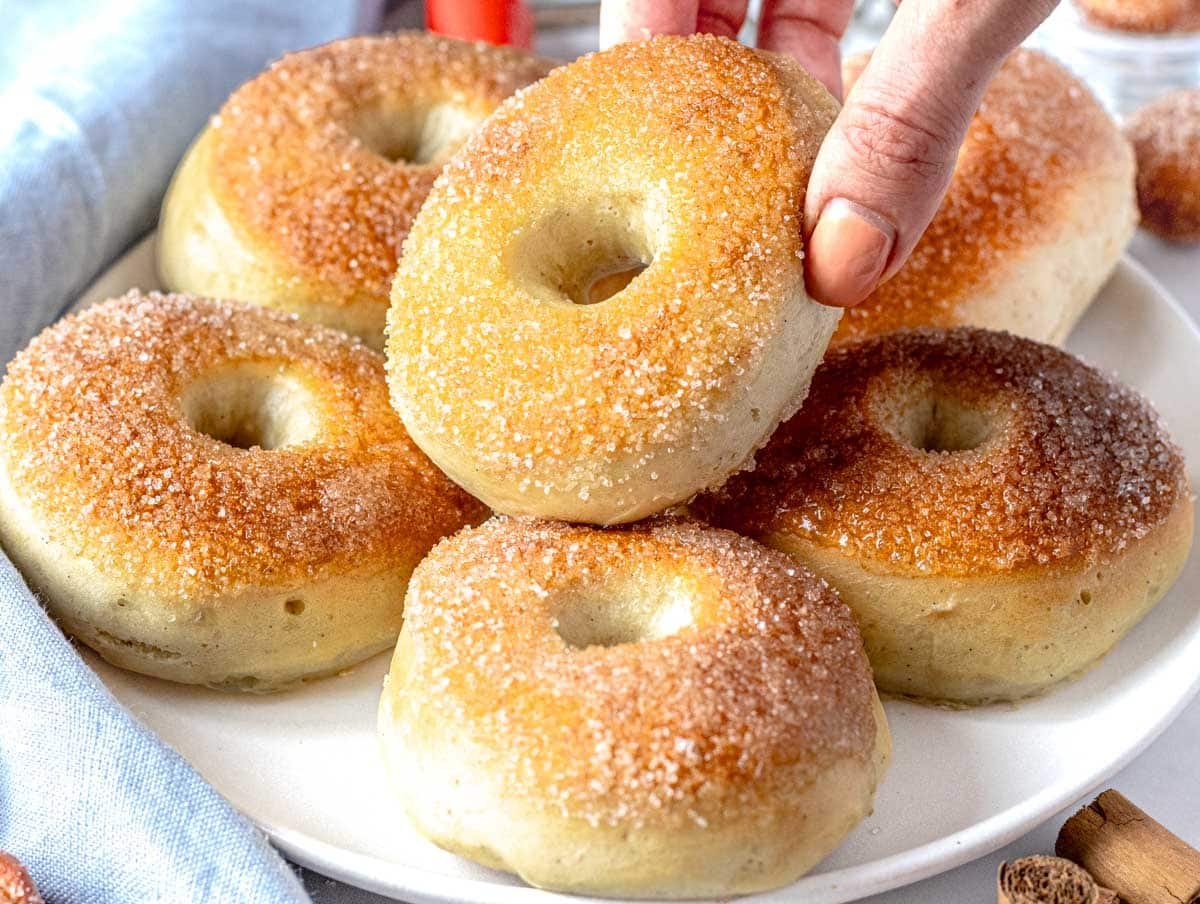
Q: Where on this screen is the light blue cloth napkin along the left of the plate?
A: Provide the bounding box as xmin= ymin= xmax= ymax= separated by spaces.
xmin=0 ymin=0 xmax=378 ymax=904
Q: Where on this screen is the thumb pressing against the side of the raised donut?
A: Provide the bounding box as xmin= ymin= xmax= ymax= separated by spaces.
xmin=804 ymin=0 xmax=1056 ymax=306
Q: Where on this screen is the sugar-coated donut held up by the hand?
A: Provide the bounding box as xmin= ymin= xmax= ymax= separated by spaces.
xmin=388 ymin=35 xmax=839 ymax=523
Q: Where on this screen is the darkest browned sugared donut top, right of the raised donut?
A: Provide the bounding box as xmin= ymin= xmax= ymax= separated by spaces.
xmin=696 ymin=328 xmax=1189 ymax=575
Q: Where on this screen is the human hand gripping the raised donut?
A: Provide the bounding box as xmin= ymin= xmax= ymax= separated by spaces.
xmin=600 ymin=0 xmax=1058 ymax=306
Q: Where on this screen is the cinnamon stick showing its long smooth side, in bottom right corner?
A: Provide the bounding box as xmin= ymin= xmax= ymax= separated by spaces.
xmin=1055 ymin=790 xmax=1200 ymax=904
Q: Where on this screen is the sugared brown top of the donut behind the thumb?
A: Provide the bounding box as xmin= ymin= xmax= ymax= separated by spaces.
xmin=834 ymin=49 xmax=1122 ymax=343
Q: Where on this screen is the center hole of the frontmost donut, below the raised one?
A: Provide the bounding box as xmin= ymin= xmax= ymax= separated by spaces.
xmin=551 ymin=583 xmax=694 ymax=649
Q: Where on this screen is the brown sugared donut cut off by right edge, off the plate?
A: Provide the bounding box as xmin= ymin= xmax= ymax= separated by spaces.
xmin=1126 ymin=88 xmax=1200 ymax=241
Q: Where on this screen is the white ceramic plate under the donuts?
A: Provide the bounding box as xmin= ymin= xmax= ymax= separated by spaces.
xmin=77 ymin=241 xmax=1200 ymax=904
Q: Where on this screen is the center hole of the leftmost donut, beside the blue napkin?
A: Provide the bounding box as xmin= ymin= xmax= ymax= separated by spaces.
xmin=181 ymin=365 xmax=317 ymax=450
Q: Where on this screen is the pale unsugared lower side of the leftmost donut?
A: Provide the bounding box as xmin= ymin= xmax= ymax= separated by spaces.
xmin=0 ymin=460 xmax=412 ymax=693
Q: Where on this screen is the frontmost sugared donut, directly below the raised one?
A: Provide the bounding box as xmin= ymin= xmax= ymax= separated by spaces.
xmin=378 ymin=519 xmax=892 ymax=898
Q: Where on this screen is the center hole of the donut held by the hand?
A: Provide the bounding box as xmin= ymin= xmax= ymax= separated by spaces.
xmin=510 ymin=194 xmax=654 ymax=305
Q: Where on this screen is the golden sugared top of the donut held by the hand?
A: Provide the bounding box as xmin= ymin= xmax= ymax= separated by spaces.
xmin=388 ymin=35 xmax=836 ymax=486
